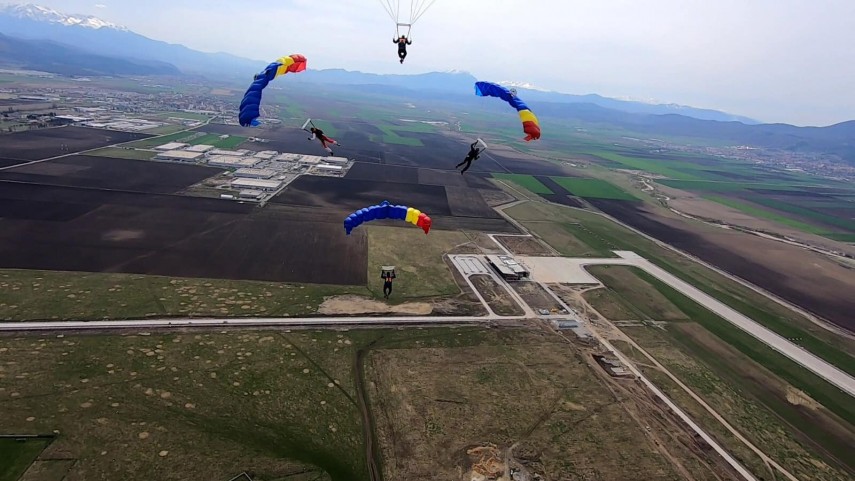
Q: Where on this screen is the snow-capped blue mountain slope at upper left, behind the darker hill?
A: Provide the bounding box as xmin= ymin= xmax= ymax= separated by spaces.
xmin=0 ymin=5 xmax=263 ymax=79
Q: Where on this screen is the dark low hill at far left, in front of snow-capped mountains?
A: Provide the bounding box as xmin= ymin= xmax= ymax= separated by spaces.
xmin=0 ymin=33 xmax=180 ymax=76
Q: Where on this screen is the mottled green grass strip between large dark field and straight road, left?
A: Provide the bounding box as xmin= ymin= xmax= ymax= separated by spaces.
xmin=0 ymin=269 xmax=362 ymax=321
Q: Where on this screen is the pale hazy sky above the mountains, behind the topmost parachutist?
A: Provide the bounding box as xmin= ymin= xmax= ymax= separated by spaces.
xmin=0 ymin=0 xmax=855 ymax=126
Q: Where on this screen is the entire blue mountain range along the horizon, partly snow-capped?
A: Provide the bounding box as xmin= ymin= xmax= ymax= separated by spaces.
xmin=0 ymin=4 xmax=855 ymax=164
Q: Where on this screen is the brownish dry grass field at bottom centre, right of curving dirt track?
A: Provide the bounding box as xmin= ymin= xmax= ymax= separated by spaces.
xmin=366 ymin=329 xmax=729 ymax=481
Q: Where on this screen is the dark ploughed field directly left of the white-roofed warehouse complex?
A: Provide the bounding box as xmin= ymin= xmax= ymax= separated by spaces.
xmin=0 ymin=155 xmax=223 ymax=194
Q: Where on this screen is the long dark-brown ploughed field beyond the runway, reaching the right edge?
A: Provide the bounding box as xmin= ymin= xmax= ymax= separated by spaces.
xmin=590 ymin=200 xmax=855 ymax=330
